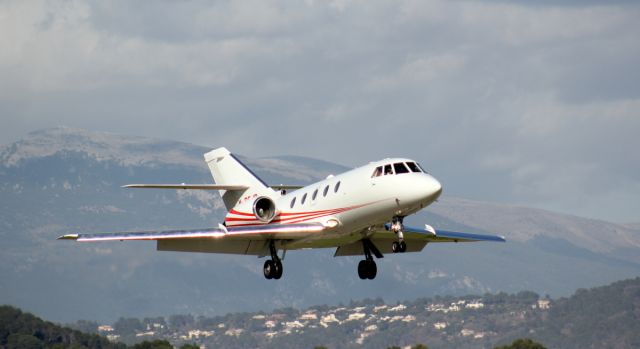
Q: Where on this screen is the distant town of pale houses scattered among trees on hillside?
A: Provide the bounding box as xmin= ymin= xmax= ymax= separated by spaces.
xmin=85 ymin=292 xmax=552 ymax=349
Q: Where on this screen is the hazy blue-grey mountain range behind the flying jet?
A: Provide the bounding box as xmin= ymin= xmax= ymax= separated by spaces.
xmin=0 ymin=128 xmax=640 ymax=321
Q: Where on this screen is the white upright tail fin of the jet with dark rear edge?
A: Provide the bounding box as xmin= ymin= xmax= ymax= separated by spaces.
xmin=204 ymin=147 xmax=273 ymax=210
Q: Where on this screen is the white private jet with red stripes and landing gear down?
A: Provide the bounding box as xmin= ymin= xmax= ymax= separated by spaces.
xmin=58 ymin=147 xmax=506 ymax=280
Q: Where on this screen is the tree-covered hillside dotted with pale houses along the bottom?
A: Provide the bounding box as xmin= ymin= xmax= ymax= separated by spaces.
xmin=63 ymin=278 xmax=640 ymax=349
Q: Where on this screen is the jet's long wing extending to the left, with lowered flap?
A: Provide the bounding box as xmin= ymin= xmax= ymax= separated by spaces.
xmin=58 ymin=223 xmax=324 ymax=256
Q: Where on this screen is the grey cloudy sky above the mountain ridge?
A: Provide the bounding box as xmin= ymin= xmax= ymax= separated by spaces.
xmin=0 ymin=0 xmax=640 ymax=223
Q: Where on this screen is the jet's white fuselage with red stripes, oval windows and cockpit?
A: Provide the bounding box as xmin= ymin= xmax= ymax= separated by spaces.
xmin=225 ymin=158 xmax=442 ymax=247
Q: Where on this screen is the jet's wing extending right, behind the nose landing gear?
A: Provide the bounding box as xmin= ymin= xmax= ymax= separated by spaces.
xmin=334 ymin=224 xmax=506 ymax=257
